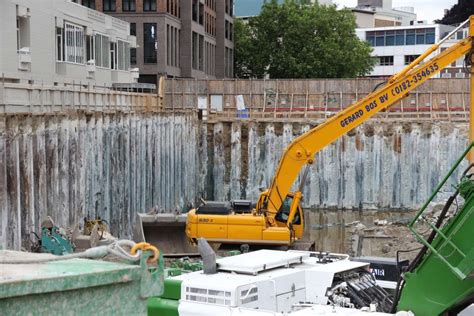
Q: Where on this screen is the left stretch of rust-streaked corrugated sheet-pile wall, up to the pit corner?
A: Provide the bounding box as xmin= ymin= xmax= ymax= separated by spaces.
xmin=0 ymin=112 xmax=198 ymax=249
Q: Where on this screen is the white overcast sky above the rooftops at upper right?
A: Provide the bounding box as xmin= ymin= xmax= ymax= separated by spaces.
xmin=333 ymin=0 xmax=458 ymax=23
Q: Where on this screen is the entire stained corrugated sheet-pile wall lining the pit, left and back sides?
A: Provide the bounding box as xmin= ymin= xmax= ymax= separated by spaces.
xmin=0 ymin=85 xmax=468 ymax=249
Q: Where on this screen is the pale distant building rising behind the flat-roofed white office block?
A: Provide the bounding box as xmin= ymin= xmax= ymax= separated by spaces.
xmin=352 ymin=0 xmax=416 ymax=28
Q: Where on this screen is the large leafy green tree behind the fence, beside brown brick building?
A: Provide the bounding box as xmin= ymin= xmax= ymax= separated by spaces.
xmin=234 ymin=0 xmax=375 ymax=78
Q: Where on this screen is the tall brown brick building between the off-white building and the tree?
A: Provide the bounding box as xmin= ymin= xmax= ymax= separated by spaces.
xmin=76 ymin=0 xmax=234 ymax=83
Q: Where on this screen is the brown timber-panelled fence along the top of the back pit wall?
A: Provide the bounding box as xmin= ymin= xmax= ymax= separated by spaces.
xmin=164 ymin=78 xmax=469 ymax=121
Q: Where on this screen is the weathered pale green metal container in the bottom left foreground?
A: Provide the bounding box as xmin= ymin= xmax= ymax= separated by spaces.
xmin=0 ymin=251 xmax=163 ymax=315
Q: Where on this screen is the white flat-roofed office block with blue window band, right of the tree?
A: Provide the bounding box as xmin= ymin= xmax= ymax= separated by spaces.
xmin=356 ymin=24 xmax=454 ymax=77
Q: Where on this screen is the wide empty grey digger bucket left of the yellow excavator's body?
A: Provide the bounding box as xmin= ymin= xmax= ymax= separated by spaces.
xmin=133 ymin=213 xmax=199 ymax=257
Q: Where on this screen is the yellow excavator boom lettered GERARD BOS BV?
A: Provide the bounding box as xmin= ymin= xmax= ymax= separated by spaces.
xmin=256 ymin=17 xmax=474 ymax=226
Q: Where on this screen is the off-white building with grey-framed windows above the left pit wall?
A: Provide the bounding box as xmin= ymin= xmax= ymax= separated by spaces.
xmin=0 ymin=0 xmax=138 ymax=86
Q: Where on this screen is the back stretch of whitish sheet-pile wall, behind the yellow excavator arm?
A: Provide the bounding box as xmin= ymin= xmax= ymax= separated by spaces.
xmin=200 ymin=120 xmax=467 ymax=209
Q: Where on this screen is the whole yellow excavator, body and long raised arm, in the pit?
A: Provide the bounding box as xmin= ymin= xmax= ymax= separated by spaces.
xmin=186 ymin=17 xmax=474 ymax=249
